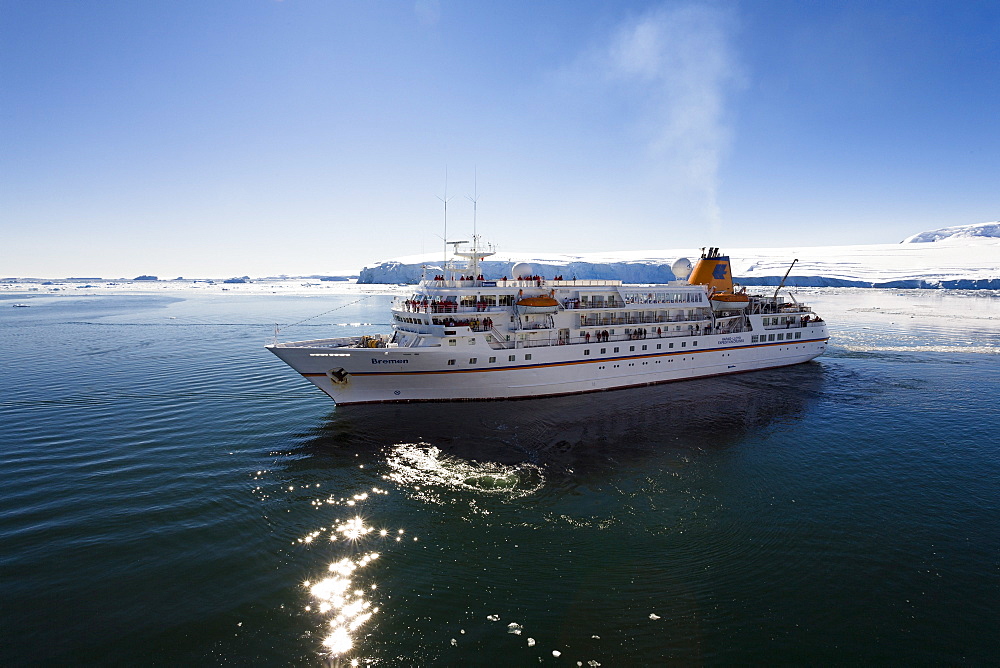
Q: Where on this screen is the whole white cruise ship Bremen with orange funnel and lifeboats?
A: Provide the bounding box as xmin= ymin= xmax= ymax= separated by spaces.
xmin=267 ymin=242 xmax=829 ymax=404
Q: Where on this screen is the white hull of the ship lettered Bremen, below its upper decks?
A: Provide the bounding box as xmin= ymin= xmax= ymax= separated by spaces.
xmin=268 ymin=323 xmax=829 ymax=404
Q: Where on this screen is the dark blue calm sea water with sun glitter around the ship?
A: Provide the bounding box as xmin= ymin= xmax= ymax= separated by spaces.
xmin=0 ymin=290 xmax=1000 ymax=666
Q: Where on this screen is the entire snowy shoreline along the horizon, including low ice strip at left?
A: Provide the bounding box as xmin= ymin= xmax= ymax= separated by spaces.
xmin=0 ymin=223 xmax=1000 ymax=295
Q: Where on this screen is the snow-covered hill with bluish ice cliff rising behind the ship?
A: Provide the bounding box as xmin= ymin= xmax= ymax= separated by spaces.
xmin=358 ymin=222 xmax=1000 ymax=289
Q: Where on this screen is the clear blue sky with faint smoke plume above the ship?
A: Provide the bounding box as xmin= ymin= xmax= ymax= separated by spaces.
xmin=0 ymin=0 xmax=1000 ymax=278
